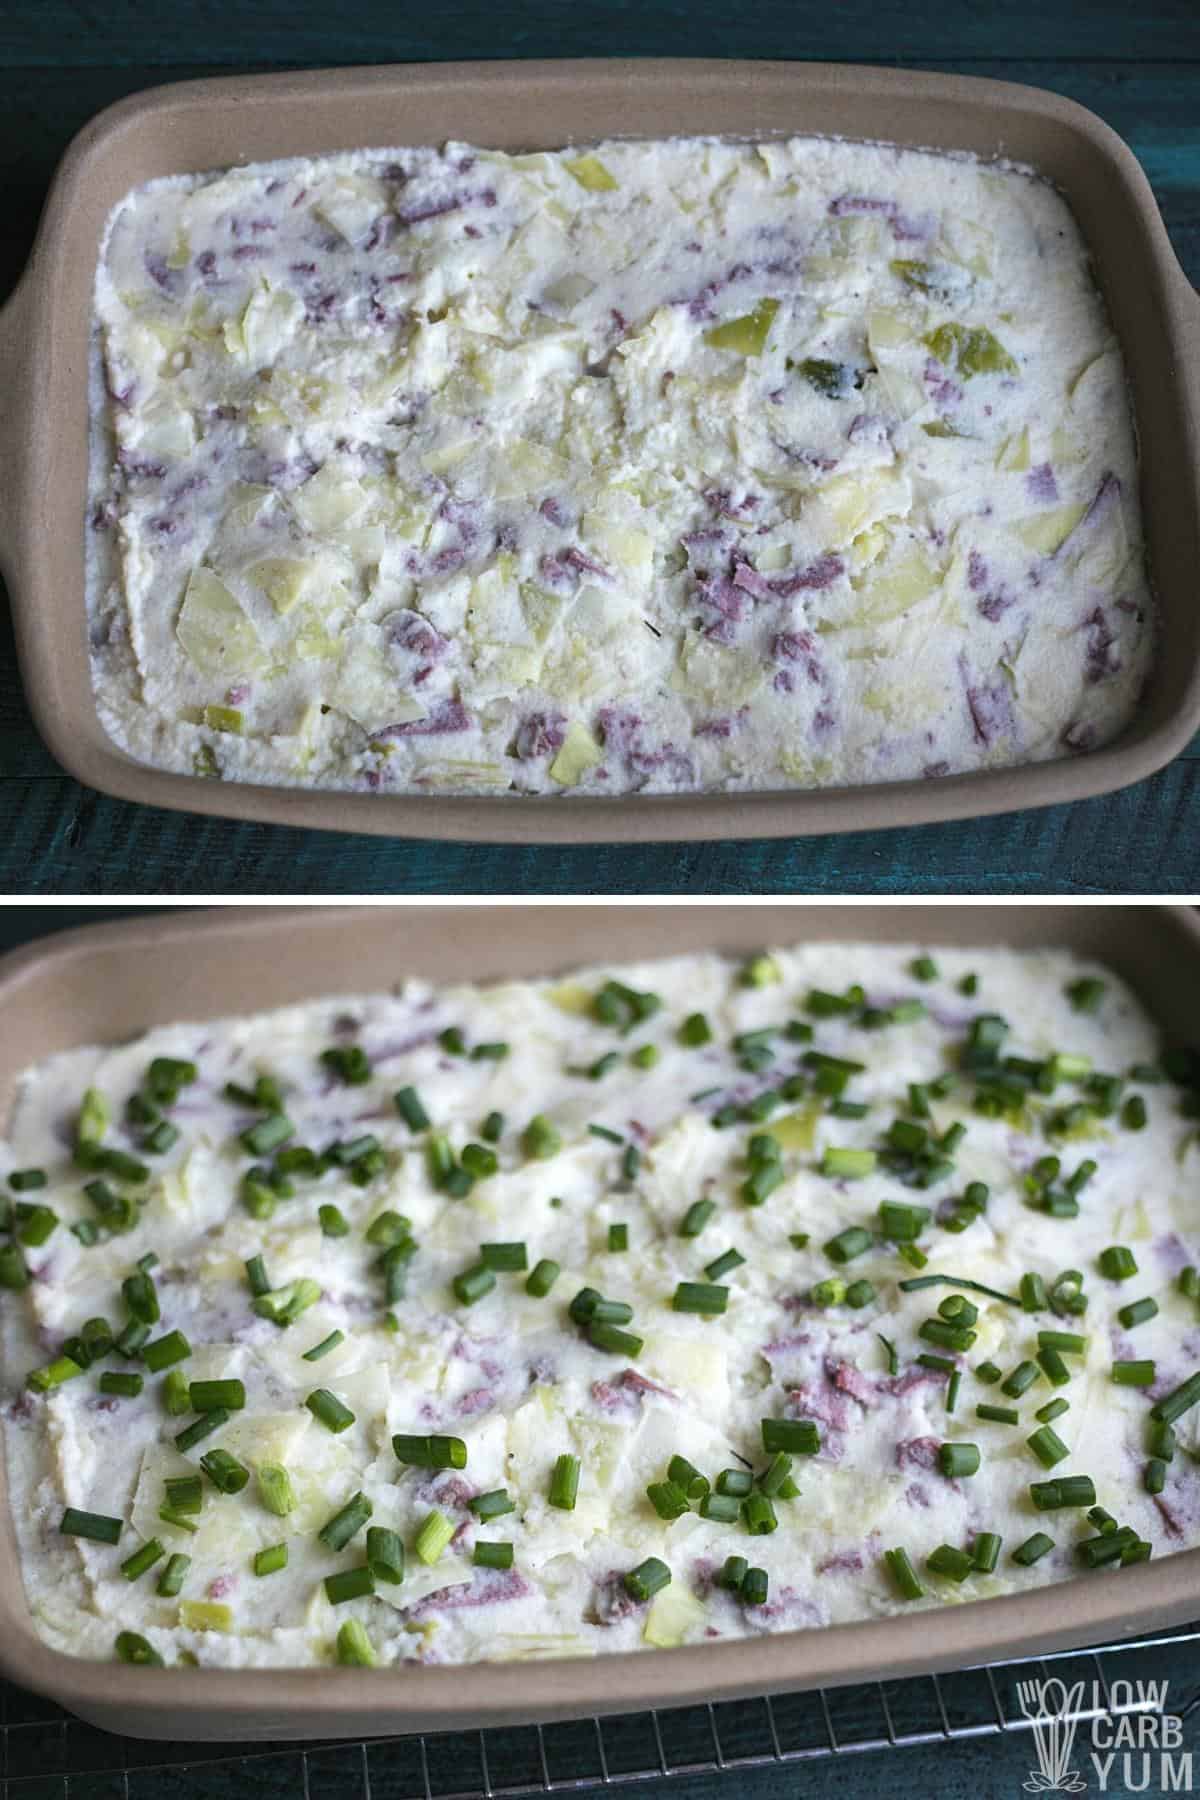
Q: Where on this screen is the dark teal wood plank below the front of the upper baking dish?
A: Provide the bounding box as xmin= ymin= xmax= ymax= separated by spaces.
xmin=0 ymin=760 xmax=1200 ymax=896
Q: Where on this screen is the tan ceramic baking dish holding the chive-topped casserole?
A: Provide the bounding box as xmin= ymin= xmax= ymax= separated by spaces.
xmin=0 ymin=904 xmax=1200 ymax=1739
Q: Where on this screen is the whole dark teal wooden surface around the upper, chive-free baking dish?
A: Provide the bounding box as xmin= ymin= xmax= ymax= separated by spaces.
xmin=0 ymin=0 xmax=1200 ymax=895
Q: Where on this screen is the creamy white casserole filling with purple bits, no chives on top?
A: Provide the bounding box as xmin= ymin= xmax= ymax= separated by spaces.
xmin=88 ymin=139 xmax=1151 ymax=794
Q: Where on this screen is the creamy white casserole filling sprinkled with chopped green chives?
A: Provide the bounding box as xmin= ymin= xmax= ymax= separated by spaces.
xmin=0 ymin=945 xmax=1200 ymax=1665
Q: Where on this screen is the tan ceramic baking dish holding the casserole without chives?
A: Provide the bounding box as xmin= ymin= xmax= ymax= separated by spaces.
xmin=0 ymin=59 xmax=1200 ymax=842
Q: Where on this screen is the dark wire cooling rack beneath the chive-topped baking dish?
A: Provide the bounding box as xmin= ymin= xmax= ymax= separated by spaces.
xmin=0 ymin=1625 xmax=1200 ymax=1800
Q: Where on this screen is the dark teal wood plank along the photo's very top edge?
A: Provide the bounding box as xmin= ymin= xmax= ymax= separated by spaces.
xmin=0 ymin=0 xmax=1200 ymax=68
